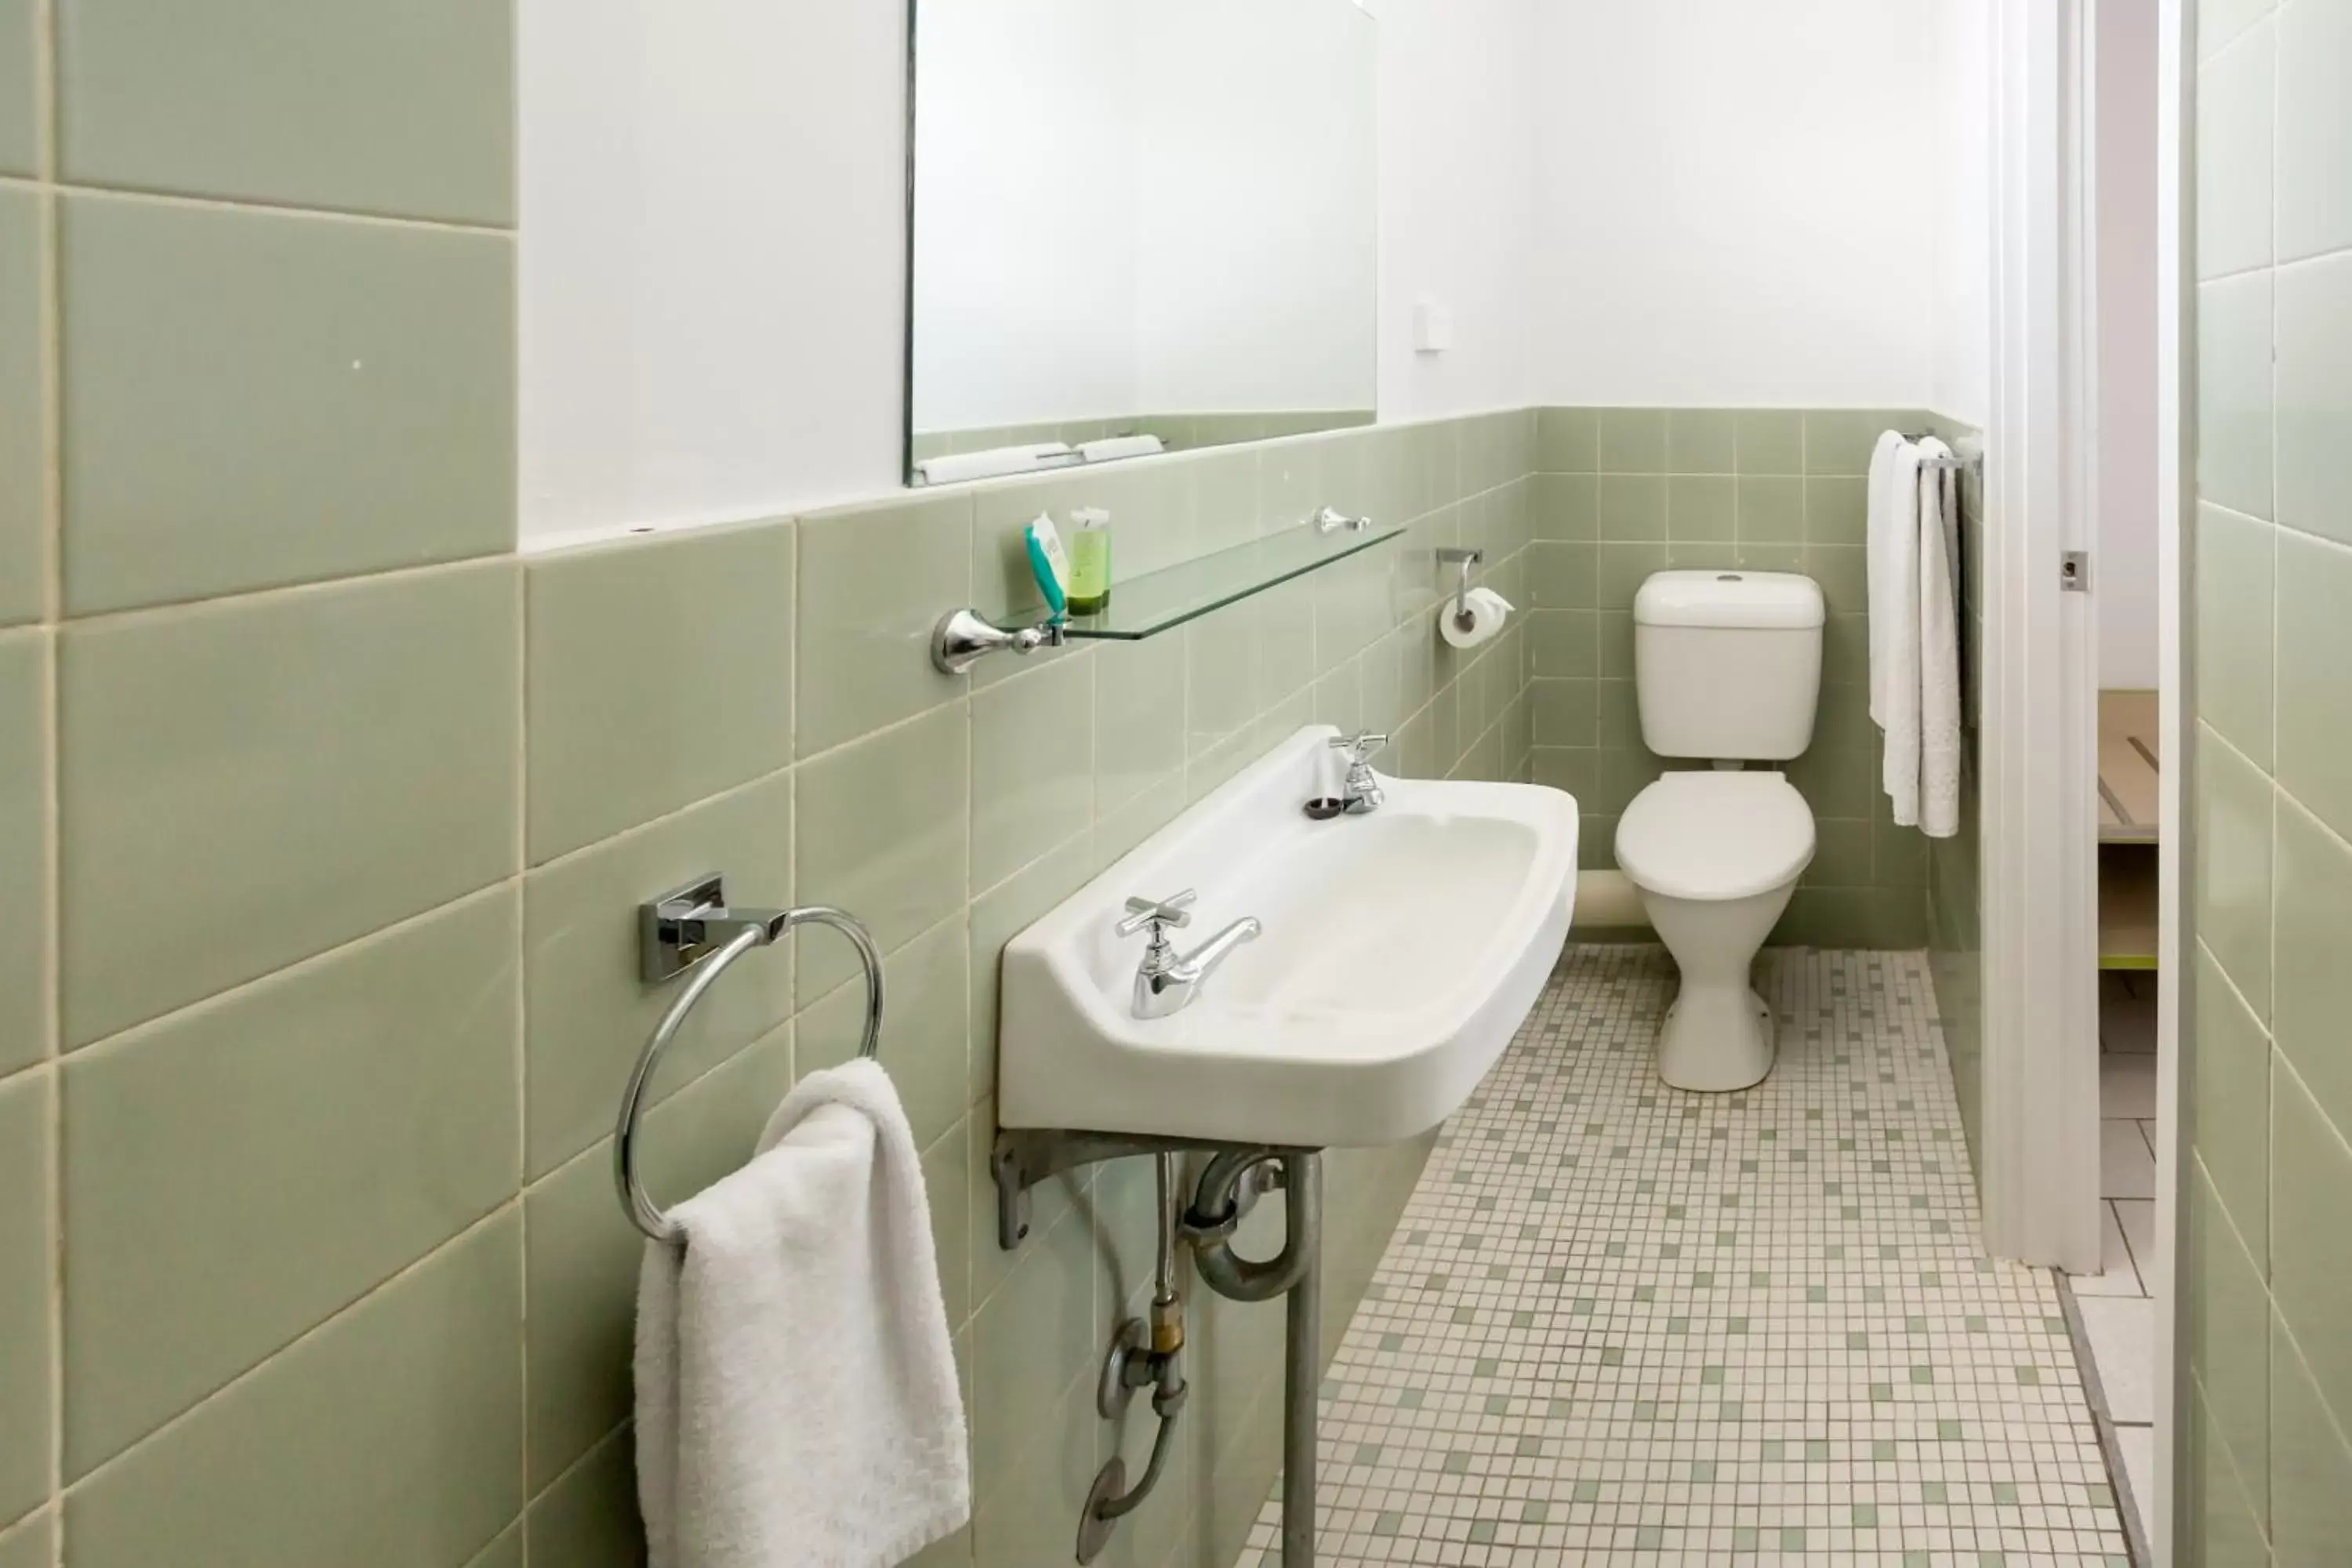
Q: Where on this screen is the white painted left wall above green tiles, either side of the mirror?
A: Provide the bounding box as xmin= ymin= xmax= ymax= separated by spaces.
xmin=520 ymin=0 xmax=1536 ymax=548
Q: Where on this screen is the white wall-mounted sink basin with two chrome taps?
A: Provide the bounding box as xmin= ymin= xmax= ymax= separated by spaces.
xmin=997 ymin=727 xmax=1576 ymax=1149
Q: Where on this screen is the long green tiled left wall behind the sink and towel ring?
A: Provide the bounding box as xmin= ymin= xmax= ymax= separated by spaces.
xmin=0 ymin=58 xmax=1536 ymax=1542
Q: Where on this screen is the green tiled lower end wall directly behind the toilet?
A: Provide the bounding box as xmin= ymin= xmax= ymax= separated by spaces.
xmin=1529 ymin=409 xmax=1957 ymax=947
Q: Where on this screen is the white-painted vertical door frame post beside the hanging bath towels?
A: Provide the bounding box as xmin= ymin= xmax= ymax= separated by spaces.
xmin=1980 ymin=0 xmax=2100 ymax=1272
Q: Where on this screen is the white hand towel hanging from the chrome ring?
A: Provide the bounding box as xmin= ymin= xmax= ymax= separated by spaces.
xmin=637 ymin=1060 xmax=971 ymax=1568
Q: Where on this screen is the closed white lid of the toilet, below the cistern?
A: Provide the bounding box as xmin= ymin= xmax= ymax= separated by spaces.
xmin=1618 ymin=771 xmax=1813 ymax=900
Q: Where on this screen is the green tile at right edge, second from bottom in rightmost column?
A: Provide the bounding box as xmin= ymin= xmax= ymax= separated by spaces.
xmin=2270 ymin=1069 xmax=2352 ymax=1410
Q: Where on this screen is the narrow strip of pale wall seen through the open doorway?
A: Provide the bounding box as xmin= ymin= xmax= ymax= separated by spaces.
xmin=2091 ymin=5 xmax=2159 ymax=689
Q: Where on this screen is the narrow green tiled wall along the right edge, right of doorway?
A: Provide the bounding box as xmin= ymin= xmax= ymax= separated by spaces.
xmin=2173 ymin=0 xmax=2352 ymax=1568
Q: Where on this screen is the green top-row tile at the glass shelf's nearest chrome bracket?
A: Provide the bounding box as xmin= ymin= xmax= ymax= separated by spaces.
xmin=797 ymin=494 xmax=969 ymax=757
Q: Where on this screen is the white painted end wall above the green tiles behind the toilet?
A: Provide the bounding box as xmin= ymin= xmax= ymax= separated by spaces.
xmin=1534 ymin=0 xmax=1950 ymax=407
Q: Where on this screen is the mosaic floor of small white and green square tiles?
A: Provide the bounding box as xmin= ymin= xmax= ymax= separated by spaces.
xmin=1242 ymin=947 xmax=2129 ymax=1568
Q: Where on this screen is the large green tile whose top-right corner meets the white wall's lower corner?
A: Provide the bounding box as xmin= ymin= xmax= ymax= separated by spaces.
xmin=59 ymin=562 xmax=522 ymax=1046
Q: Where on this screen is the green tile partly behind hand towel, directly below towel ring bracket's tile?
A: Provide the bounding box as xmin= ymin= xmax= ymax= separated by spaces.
xmin=524 ymin=1027 xmax=795 ymax=1490
